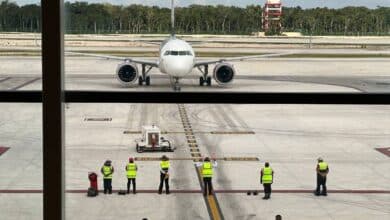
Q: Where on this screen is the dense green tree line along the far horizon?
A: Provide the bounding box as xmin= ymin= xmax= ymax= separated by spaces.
xmin=0 ymin=0 xmax=390 ymax=35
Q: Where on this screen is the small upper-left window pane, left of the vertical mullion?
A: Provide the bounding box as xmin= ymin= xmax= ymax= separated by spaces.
xmin=0 ymin=0 xmax=42 ymax=91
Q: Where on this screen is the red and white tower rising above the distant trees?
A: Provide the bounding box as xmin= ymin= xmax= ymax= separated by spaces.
xmin=262 ymin=0 xmax=282 ymax=35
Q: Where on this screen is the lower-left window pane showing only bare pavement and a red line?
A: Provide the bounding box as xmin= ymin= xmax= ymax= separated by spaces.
xmin=0 ymin=103 xmax=43 ymax=220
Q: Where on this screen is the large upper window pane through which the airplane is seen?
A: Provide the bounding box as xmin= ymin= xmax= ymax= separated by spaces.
xmin=65 ymin=0 xmax=390 ymax=93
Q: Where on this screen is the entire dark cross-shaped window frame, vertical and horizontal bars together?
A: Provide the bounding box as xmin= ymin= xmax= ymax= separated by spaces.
xmin=0 ymin=0 xmax=390 ymax=220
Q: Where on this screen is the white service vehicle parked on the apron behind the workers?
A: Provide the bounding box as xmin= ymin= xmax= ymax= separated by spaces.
xmin=135 ymin=125 xmax=175 ymax=153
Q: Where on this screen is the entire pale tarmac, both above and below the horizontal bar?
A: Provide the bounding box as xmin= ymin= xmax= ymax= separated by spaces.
xmin=0 ymin=47 xmax=390 ymax=220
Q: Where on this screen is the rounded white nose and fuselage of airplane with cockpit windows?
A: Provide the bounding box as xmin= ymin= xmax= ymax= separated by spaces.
xmin=158 ymin=37 xmax=195 ymax=78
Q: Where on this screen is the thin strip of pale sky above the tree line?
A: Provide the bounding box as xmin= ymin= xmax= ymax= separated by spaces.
xmin=10 ymin=0 xmax=390 ymax=8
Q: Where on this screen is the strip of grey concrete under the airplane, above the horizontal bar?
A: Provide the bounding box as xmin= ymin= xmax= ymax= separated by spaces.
xmin=0 ymin=57 xmax=390 ymax=93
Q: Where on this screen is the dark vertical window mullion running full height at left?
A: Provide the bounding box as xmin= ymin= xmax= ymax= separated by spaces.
xmin=41 ymin=0 xmax=65 ymax=220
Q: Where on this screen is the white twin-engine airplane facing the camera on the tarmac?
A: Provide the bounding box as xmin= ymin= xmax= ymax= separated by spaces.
xmin=68 ymin=0 xmax=291 ymax=91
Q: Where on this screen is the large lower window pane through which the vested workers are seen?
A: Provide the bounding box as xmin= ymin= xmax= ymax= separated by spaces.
xmin=65 ymin=103 xmax=390 ymax=219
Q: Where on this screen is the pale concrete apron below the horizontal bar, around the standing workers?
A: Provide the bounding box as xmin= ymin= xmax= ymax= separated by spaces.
xmin=0 ymin=103 xmax=390 ymax=219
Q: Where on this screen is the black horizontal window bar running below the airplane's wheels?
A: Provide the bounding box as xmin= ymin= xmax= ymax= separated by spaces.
xmin=0 ymin=91 xmax=390 ymax=105
